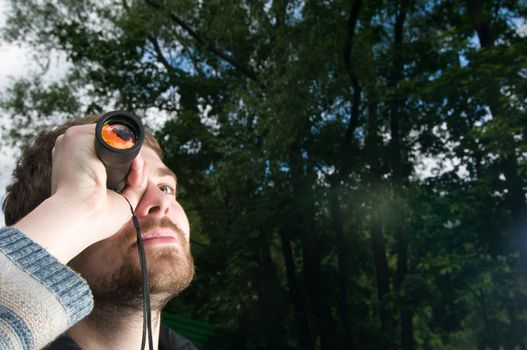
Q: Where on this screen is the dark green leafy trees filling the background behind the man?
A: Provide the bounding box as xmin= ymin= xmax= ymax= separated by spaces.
xmin=0 ymin=0 xmax=527 ymax=350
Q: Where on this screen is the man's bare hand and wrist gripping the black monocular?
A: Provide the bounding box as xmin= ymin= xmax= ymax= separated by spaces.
xmin=15 ymin=124 xmax=148 ymax=262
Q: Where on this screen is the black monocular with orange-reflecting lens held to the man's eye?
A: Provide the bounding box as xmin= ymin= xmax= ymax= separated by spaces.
xmin=95 ymin=111 xmax=145 ymax=192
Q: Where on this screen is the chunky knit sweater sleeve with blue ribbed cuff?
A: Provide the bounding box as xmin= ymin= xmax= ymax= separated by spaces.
xmin=0 ymin=227 xmax=93 ymax=350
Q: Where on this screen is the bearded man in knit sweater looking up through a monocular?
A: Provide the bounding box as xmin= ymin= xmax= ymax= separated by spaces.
xmin=0 ymin=113 xmax=195 ymax=350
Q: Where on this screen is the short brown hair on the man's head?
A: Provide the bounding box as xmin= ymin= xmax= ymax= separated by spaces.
xmin=3 ymin=115 xmax=162 ymax=225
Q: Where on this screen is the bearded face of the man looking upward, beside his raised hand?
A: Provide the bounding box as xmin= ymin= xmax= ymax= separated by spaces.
xmin=70 ymin=146 xmax=194 ymax=309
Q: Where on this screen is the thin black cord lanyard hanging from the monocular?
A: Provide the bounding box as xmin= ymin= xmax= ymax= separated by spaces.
xmin=123 ymin=196 xmax=154 ymax=350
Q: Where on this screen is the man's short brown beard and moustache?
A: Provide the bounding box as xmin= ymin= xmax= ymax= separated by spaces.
xmin=72 ymin=218 xmax=194 ymax=317
